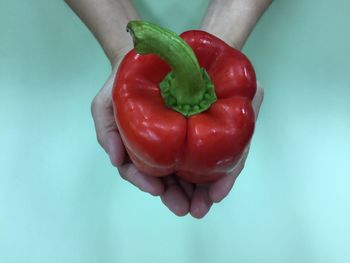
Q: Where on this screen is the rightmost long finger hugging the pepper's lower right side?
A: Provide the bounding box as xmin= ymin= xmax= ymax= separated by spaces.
xmin=209 ymin=148 xmax=249 ymax=203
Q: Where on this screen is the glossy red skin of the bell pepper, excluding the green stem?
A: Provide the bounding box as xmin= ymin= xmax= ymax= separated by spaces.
xmin=112 ymin=21 xmax=256 ymax=183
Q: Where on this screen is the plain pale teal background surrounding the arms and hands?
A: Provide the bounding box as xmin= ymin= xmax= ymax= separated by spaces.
xmin=0 ymin=0 xmax=350 ymax=263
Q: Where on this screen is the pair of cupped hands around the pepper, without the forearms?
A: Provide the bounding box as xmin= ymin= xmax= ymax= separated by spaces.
xmin=91 ymin=53 xmax=263 ymax=218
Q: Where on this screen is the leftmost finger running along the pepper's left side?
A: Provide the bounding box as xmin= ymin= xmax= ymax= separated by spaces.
xmin=91 ymin=75 xmax=125 ymax=166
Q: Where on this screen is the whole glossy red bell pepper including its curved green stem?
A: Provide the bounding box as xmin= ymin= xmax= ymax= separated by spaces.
xmin=112 ymin=21 xmax=256 ymax=183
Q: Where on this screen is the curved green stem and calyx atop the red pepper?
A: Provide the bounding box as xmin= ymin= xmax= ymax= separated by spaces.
xmin=127 ymin=21 xmax=217 ymax=117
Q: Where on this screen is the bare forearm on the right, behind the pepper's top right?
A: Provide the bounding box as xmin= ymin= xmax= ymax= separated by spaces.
xmin=201 ymin=0 xmax=272 ymax=49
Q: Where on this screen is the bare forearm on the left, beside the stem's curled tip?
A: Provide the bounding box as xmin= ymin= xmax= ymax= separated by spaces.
xmin=65 ymin=0 xmax=139 ymax=65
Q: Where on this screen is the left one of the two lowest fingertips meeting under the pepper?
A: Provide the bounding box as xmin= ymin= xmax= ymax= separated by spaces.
xmin=161 ymin=176 xmax=190 ymax=216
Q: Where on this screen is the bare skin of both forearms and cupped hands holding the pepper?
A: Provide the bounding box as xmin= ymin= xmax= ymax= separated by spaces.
xmin=66 ymin=0 xmax=272 ymax=218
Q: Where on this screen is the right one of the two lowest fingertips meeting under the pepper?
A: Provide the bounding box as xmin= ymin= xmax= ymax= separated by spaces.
xmin=190 ymin=185 xmax=213 ymax=219
